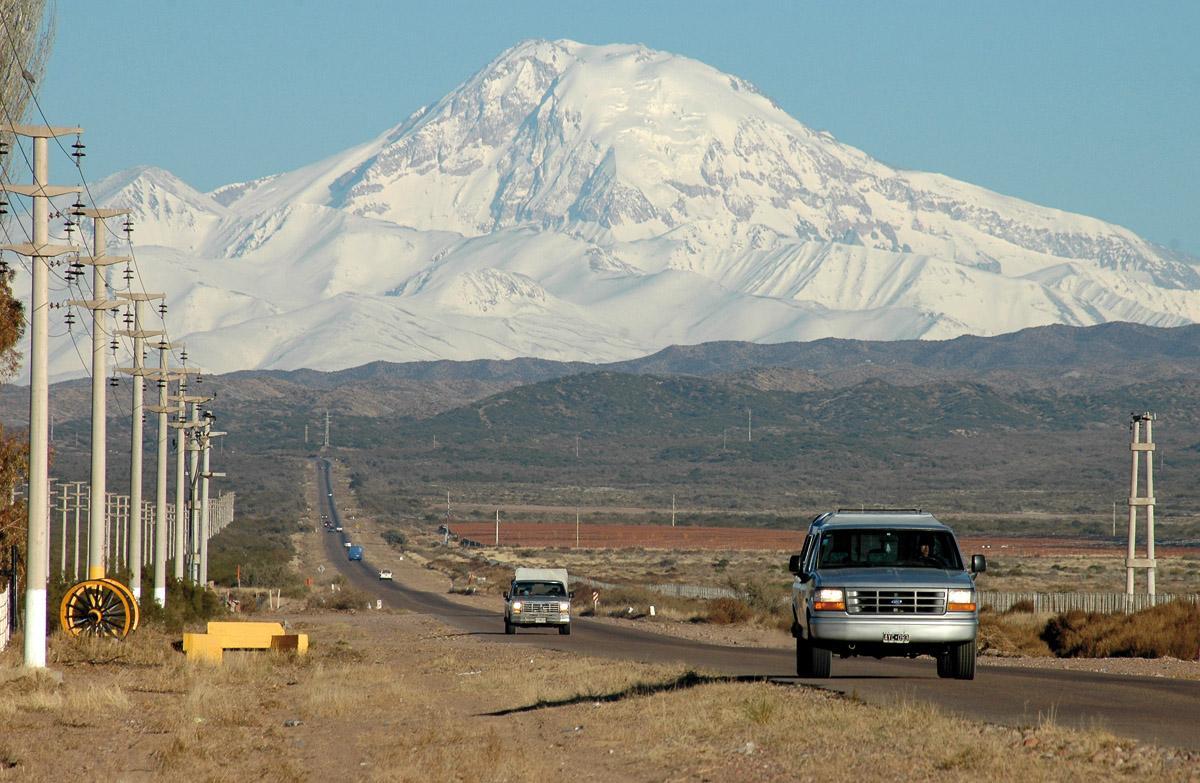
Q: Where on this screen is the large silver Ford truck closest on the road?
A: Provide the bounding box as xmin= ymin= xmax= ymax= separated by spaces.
xmin=788 ymin=510 xmax=986 ymax=680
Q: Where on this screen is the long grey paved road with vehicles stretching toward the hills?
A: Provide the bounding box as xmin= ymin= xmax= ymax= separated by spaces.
xmin=317 ymin=461 xmax=1200 ymax=749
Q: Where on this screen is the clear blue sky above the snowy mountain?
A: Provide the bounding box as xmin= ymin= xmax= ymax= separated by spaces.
xmin=30 ymin=0 xmax=1200 ymax=256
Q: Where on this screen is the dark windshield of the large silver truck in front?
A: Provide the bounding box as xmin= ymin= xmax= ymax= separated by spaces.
xmin=817 ymin=528 xmax=962 ymax=570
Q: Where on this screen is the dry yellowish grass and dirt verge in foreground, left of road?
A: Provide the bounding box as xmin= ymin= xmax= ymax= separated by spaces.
xmin=0 ymin=595 xmax=1200 ymax=782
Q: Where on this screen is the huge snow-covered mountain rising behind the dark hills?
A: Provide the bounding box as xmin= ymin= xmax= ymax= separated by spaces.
xmin=11 ymin=41 xmax=1200 ymax=377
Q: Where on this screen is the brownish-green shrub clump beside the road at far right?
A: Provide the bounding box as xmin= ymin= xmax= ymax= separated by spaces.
xmin=1042 ymin=602 xmax=1200 ymax=661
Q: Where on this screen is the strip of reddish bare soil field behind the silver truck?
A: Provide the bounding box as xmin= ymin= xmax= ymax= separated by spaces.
xmin=450 ymin=521 xmax=1200 ymax=557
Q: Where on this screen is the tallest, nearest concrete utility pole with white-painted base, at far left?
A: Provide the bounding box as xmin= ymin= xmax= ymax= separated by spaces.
xmin=0 ymin=122 xmax=83 ymax=669
